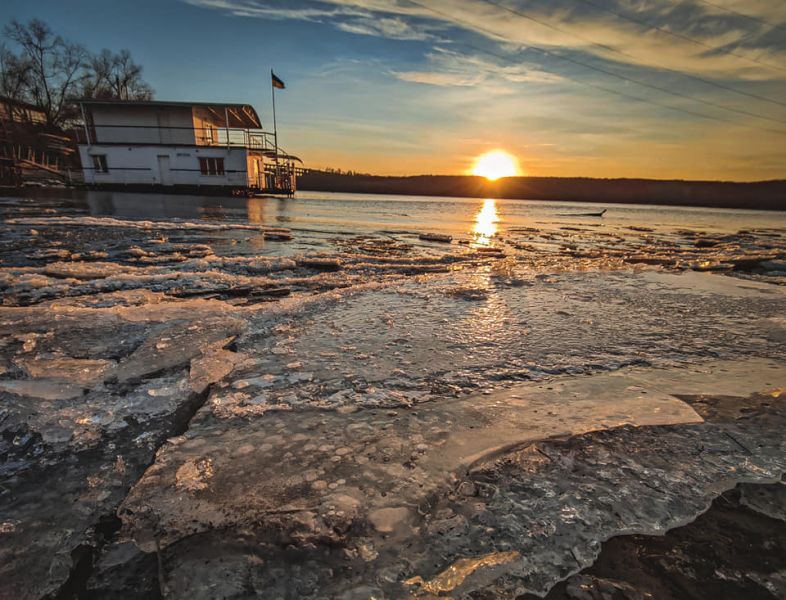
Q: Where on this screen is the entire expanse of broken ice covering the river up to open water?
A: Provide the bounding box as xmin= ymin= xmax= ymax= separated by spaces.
xmin=0 ymin=196 xmax=786 ymax=598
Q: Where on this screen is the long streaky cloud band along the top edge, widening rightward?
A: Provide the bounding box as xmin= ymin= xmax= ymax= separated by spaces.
xmin=186 ymin=0 xmax=786 ymax=80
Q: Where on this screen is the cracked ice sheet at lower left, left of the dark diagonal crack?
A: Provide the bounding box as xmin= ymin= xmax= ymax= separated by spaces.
xmin=0 ymin=296 xmax=251 ymax=598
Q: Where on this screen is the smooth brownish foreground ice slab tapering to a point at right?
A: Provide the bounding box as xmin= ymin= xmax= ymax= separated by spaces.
xmin=119 ymin=363 xmax=768 ymax=545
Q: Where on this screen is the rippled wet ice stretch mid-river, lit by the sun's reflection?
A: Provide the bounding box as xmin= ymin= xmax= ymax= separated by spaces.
xmin=214 ymin=267 xmax=784 ymax=412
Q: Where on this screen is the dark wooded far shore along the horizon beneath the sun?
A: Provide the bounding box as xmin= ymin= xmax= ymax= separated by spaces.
xmin=298 ymin=171 xmax=786 ymax=210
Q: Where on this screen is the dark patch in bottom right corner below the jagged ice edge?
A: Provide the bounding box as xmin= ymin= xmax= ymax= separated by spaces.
xmin=532 ymin=483 xmax=786 ymax=600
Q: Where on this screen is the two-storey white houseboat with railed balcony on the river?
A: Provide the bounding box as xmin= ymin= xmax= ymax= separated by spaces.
xmin=79 ymin=100 xmax=300 ymax=194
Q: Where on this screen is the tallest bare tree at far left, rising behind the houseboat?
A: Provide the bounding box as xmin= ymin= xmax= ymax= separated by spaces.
xmin=5 ymin=19 xmax=87 ymax=126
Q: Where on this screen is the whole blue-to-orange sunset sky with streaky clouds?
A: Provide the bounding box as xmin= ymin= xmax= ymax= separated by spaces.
xmin=0 ymin=0 xmax=786 ymax=181
